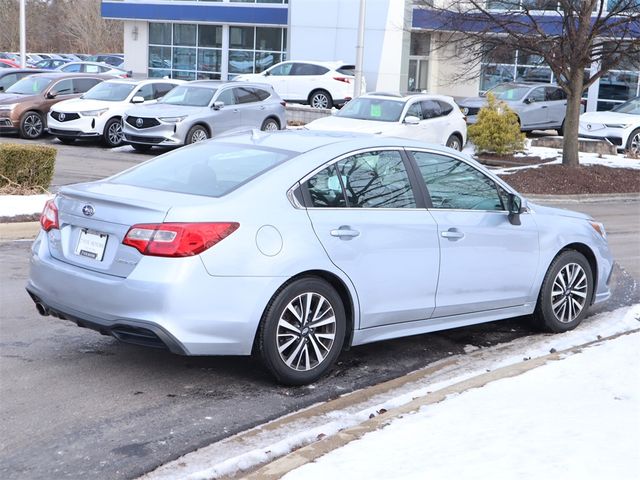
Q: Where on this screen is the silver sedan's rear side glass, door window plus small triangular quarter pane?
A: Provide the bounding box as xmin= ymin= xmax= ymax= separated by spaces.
xmin=307 ymin=150 xmax=416 ymax=208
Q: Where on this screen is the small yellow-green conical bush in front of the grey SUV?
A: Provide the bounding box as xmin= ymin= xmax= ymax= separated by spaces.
xmin=468 ymin=93 xmax=525 ymax=155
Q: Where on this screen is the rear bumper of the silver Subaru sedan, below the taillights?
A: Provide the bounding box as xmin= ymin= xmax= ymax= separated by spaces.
xmin=26 ymin=231 xmax=286 ymax=355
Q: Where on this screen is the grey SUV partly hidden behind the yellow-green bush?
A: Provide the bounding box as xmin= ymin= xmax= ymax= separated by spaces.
xmin=458 ymin=82 xmax=567 ymax=135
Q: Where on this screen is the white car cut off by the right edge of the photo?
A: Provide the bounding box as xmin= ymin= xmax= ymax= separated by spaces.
xmin=578 ymin=97 xmax=640 ymax=154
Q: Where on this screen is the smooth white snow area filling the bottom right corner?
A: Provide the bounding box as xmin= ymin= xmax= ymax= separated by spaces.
xmin=283 ymin=332 xmax=640 ymax=480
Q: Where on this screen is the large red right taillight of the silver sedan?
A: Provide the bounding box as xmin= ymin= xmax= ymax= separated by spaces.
xmin=122 ymin=222 xmax=240 ymax=257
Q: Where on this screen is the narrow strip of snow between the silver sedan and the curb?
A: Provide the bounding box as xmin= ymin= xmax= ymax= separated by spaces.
xmin=142 ymin=304 xmax=640 ymax=480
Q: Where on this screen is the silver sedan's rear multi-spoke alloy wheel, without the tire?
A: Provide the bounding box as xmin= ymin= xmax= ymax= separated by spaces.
xmin=276 ymin=292 xmax=336 ymax=372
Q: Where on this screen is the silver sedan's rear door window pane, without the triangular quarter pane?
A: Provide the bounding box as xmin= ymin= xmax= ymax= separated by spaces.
xmin=332 ymin=151 xmax=416 ymax=208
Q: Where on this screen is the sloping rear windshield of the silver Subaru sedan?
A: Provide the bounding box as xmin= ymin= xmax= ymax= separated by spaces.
xmin=111 ymin=142 xmax=295 ymax=197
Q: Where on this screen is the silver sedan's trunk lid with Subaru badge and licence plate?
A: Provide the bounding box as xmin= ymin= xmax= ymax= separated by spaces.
xmin=48 ymin=182 xmax=214 ymax=277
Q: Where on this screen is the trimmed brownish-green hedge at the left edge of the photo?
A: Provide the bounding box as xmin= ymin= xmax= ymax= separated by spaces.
xmin=0 ymin=143 xmax=57 ymax=194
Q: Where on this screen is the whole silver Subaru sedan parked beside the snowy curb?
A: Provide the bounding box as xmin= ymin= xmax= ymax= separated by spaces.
xmin=27 ymin=130 xmax=613 ymax=385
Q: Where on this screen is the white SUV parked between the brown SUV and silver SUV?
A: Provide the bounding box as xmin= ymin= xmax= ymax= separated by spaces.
xmin=47 ymin=78 xmax=184 ymax=147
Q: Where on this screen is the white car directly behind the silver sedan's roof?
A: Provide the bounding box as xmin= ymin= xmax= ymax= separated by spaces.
xmin=306 ymin=93 xmax=467 ymax=150
